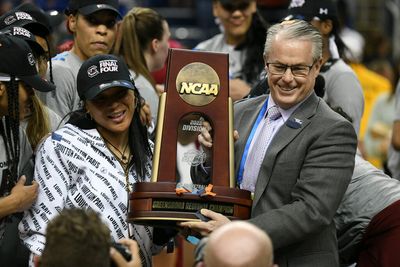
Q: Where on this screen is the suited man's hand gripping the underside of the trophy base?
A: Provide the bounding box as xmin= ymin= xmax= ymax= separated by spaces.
xmin=179 ymin=209 xmax=231 ymax=236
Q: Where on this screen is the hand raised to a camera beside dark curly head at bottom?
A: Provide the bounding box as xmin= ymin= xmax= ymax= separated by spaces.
xmin=110 ymin=238 xmax=142 ymax=267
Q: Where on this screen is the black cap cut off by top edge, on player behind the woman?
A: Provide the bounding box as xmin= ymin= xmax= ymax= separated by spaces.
xmin=65 ymin=0 xmax=121 ymax=17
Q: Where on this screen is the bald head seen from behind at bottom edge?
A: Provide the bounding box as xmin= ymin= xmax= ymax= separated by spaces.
xmin=196 ymin=221 xmax=277 ymax=267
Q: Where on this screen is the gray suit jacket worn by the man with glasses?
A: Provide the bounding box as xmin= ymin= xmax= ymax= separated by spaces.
xmin=234 ymin=93 xmax=357 ymax=267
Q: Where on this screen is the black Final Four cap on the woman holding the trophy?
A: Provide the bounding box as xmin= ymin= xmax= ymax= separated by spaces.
xmin=77 ymin=54 xmax=135 ymax=100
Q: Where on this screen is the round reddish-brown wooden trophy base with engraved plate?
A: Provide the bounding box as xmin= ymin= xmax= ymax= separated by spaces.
xmin=128 ymin=182 xmax=252 ymax=227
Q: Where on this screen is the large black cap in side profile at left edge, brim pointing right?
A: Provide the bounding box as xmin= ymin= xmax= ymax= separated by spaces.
xmin=0 ymin=34 xmax=56 ymax=92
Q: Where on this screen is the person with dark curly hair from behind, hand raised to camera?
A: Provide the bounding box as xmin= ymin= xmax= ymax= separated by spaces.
xmin=35 ymin=208 xmax=142 ymax=267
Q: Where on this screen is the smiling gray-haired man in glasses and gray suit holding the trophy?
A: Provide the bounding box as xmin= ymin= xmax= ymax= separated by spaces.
xmin=181 ymin=20 xmax=357 ymax=267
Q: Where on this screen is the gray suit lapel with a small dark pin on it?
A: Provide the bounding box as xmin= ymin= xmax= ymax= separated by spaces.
xmin=253 ymin=94 xmax=320 ymax=209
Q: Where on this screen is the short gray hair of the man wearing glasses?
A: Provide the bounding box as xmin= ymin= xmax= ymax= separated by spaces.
xmin=264 ymin=19 xmax=322 ymax=62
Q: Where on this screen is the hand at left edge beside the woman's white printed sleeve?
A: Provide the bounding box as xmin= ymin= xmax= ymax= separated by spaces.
xmin=9 ymin=175 xmax=39 ymax=212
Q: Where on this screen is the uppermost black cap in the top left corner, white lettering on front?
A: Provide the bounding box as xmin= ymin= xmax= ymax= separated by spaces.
xmin=0 ymin=9 xmax=50 ymax=37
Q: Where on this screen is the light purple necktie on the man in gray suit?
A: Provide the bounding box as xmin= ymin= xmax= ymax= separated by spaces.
xmin=240 ymin=106 xmax=281 ymax=192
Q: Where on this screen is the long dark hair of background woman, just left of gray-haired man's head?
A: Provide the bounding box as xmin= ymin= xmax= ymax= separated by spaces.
xmin=236 ymin=10 xmax=268 ymax=84
